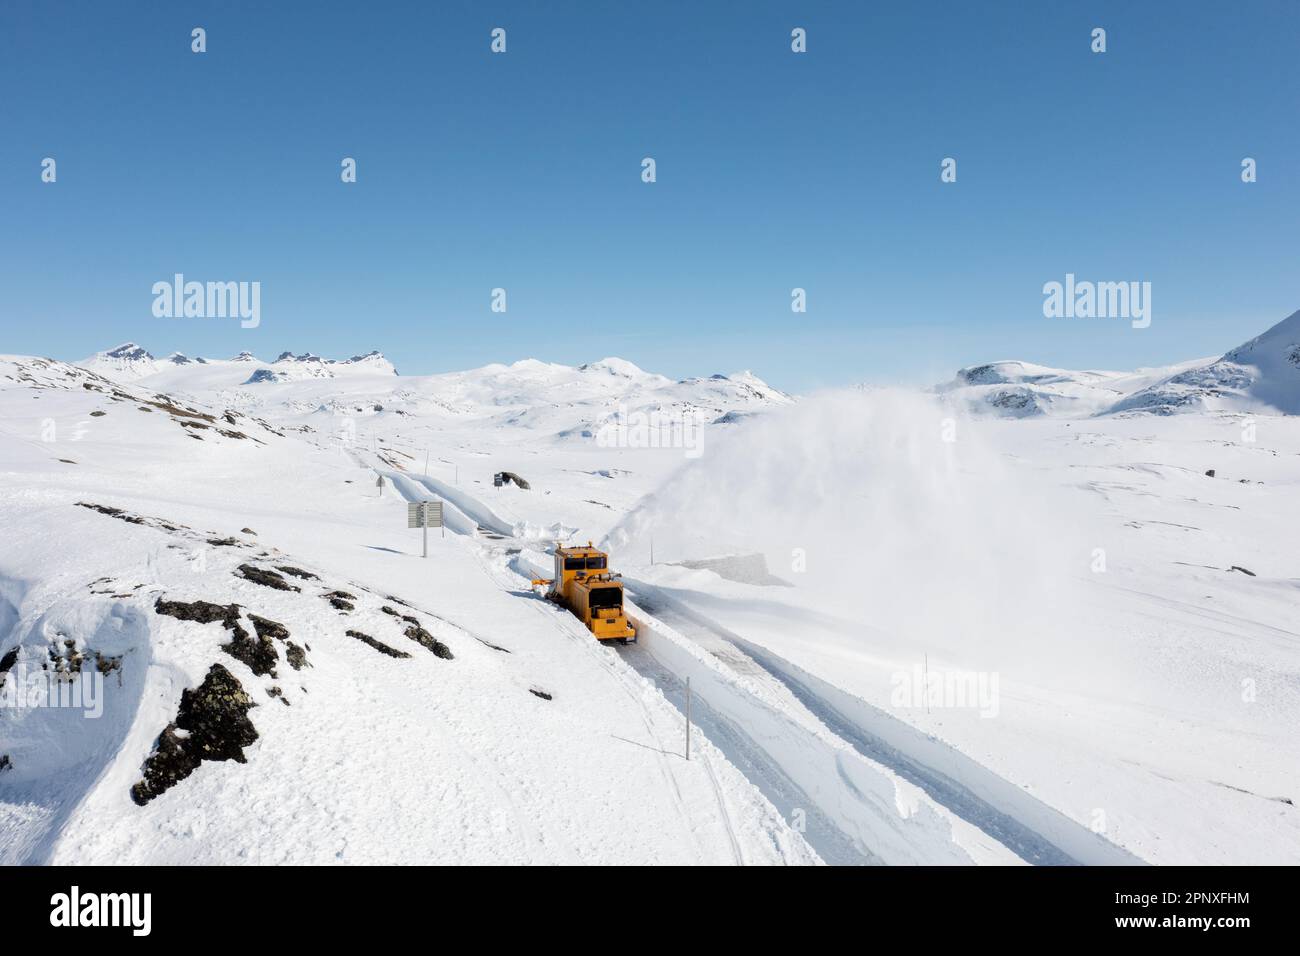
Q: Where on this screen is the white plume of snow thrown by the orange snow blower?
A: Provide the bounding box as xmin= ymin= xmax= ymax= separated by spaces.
xmin=607 ymin=390 xmax=1091 ymax=669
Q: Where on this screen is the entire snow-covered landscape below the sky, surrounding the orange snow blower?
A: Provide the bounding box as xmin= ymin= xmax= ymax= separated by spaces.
xmin=0 ymin=327 xmax=1300 ymax=864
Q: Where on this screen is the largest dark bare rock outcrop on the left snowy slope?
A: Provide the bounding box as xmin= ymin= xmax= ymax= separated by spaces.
xmin=131 ymin=663 xmax=257 ymax=806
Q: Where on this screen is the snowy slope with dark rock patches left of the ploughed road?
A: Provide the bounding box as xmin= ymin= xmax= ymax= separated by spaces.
xmin=0 ymin=356 xmax=811 ymax=864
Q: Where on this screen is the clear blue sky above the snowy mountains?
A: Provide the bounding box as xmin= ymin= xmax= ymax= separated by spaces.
xmin=0 ymin=0 xmax=1300 ymax=390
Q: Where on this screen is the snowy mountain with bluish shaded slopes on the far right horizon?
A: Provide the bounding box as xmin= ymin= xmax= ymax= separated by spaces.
xmin=936 ymin=312 xmax=1300 ymax=418
